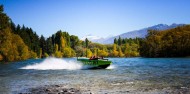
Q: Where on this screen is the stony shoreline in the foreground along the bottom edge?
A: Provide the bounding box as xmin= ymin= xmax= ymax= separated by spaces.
xmin=18 ymin=84 xmax=190 ymax=94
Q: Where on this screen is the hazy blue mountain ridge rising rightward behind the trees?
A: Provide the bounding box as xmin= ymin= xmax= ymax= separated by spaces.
xmin=98 ymin=23 xmax=185 ymax=44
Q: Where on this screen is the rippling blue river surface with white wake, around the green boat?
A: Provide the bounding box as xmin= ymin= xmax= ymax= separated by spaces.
xmin=0 ymin=57 xmax=190 ymax=94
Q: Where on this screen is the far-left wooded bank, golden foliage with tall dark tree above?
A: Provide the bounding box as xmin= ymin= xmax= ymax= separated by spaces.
xmin=0 ymin=6 xmax=32 ymax=61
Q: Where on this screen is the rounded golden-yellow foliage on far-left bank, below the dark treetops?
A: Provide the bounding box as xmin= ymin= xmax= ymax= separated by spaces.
xmin=0 ymin=28 xmax=30 ymax=61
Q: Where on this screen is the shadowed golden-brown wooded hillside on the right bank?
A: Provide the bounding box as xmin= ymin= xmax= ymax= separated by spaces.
xmin=140 ymin=25 xmax=190 ymax=57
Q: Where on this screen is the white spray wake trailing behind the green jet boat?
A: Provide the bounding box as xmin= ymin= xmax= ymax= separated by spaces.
xmin=21 ymin=57 xmax=83 ymax=70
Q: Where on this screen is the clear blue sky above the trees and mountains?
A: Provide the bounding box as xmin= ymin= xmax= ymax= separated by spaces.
xmin=0 ymin=0 xmax=190 ymax=38
